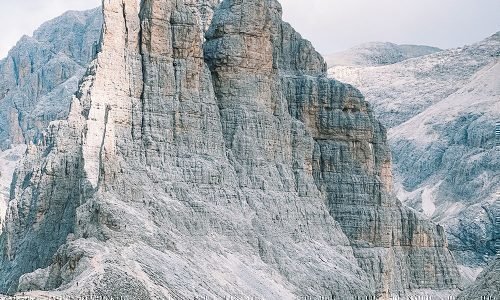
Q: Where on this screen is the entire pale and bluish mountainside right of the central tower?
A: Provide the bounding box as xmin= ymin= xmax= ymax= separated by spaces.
xmin=329 ymin=33 xmax=500 ymax=282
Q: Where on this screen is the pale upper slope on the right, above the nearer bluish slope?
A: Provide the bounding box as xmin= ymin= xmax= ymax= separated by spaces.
xmin=329 ymin=33 xmax=500 ymax=128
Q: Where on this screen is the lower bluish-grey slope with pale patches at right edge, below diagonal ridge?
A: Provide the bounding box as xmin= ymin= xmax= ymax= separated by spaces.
xmin=389 ymin=59 xmax=500 ymax=278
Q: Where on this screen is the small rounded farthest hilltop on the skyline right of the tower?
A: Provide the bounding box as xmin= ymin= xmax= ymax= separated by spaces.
xmin=325 ymin=42 xmax=442 ymax=67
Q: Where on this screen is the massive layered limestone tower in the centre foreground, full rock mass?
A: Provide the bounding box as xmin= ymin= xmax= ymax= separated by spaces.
xmin=0 ymin=0 xmax=458 ymax=299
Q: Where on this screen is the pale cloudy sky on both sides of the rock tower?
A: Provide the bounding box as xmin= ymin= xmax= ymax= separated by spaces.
xmin=0 ymin=0 xmax=500 ymax=58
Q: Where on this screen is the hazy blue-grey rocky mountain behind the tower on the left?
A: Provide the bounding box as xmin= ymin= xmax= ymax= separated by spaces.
xmin=0 ymin=9 xmax=102 ymax=230
